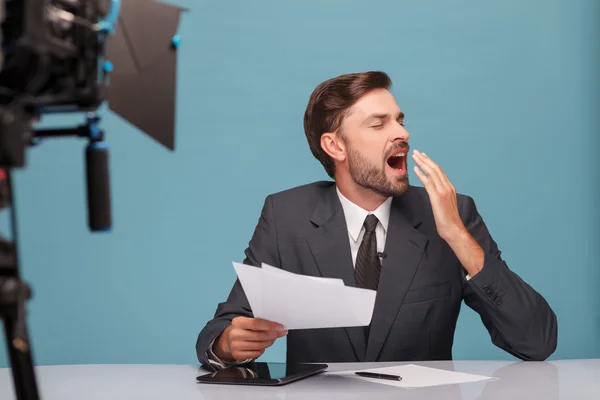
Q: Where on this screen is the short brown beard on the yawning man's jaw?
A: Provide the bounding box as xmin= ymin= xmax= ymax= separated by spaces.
xmin=348 ymin=146 xmax=409 ymax=197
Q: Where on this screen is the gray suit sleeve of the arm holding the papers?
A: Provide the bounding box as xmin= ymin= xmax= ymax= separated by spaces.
xmin=196 ymin=196 xmax=280 ymax=370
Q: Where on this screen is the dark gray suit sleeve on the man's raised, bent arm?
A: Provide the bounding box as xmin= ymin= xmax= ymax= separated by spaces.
xmin=461 ymin=196 xmax=558 ymax=361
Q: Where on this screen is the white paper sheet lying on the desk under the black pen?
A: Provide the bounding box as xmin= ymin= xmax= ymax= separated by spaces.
xmin=328 ymin=364 xmax=496 ymax=388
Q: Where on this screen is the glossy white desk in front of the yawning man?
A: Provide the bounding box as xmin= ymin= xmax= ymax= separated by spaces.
xmin=0 ymin=359 xmax=600 ymax=400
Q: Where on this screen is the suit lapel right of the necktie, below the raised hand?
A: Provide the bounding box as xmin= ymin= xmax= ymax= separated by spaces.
xmin=365 ymin=189 xmax=428 ymax=361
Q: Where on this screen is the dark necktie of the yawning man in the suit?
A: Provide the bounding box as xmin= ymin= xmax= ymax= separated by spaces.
xmin=354 ymin=214 xmax=381 ymax=290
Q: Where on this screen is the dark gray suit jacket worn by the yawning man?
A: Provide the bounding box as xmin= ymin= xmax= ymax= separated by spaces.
xmin=196 ymin=182 xmax=557 ymax=368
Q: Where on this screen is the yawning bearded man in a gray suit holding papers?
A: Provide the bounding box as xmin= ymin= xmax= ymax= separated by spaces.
xmin=196 ymin=72 xmax=557 ymax=369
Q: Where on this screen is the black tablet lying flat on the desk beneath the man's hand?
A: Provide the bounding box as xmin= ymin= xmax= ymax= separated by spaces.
xmin=196 ymin=362 xmax=327 ymax=386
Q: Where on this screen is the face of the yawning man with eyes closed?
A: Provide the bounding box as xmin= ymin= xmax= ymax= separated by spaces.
xmin=341 ymin=89 xmax=410 ymax=197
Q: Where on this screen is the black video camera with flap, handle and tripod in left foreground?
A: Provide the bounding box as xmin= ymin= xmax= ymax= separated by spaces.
xmin=0 ymin=0 xmax=181 ymax=399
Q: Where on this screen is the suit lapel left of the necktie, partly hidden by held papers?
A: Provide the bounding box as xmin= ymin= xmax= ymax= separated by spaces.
xmin=306 ymin=185 xmax=366 ymax=361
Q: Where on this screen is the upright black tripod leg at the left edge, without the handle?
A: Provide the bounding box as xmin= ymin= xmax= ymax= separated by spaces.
xmin=0 ymin=170 xmax=39 ymax=400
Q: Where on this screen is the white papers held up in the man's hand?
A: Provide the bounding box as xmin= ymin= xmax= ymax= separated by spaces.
xmin=233 ymin=262 xmax=376 ymax=330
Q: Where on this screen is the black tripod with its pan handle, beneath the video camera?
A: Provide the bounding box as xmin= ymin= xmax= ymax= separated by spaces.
xmin=0 ymin=113 xmax=111 ymax=400
